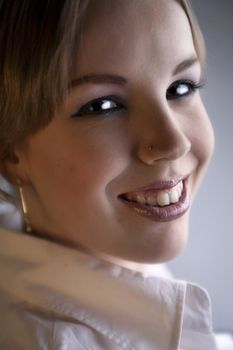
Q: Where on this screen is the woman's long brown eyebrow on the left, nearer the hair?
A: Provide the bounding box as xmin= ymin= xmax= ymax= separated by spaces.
xmin=70 ymin=74 xmax=127 ymax=88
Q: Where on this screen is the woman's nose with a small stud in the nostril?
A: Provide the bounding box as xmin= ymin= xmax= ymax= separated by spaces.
xmin=136 ymin=103 xmax=191 ymax=165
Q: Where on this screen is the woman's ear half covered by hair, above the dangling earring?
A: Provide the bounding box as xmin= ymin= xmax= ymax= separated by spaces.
xmin=0 ymin=147 xmax=28 ymax=185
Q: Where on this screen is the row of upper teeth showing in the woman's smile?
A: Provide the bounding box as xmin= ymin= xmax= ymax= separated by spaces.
xmin=126 ymin=181 xmax=183 ymax=207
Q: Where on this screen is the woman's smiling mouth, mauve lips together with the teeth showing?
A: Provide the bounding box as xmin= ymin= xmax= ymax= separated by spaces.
xmin=119 ymin=178 xmax=189 ymax=222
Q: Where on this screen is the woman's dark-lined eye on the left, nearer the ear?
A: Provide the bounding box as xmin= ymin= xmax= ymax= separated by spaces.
xmin=71 ymin=95 xmax=125 ymax=117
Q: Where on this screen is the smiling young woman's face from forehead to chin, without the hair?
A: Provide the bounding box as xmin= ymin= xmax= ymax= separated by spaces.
xmin=14 ymin=0 xmax=213 ymax=262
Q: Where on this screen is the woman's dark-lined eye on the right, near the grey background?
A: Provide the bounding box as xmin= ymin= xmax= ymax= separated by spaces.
xmin=166 ymin=80 xmax=203 ymax=100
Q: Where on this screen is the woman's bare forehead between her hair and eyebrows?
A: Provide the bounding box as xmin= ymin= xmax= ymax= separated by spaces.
xmin=72 ymin=0 xmax=195 ymax=78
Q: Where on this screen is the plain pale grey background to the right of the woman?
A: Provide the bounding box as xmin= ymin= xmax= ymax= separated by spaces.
xmin=169 ymin=0 xmax=233 ymax=332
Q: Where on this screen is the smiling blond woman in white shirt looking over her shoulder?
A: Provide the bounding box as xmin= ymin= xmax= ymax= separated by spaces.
xmin=0 ymin=0 xmax=218 ymax=350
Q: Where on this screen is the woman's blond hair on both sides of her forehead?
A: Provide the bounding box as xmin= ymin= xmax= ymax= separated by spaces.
xmin=0 ymin=0 xmax=205 ymax=191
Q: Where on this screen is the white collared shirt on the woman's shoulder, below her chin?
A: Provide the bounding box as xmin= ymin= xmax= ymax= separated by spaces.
xmin=0 ymin=229 xmax=217 ymax=350
